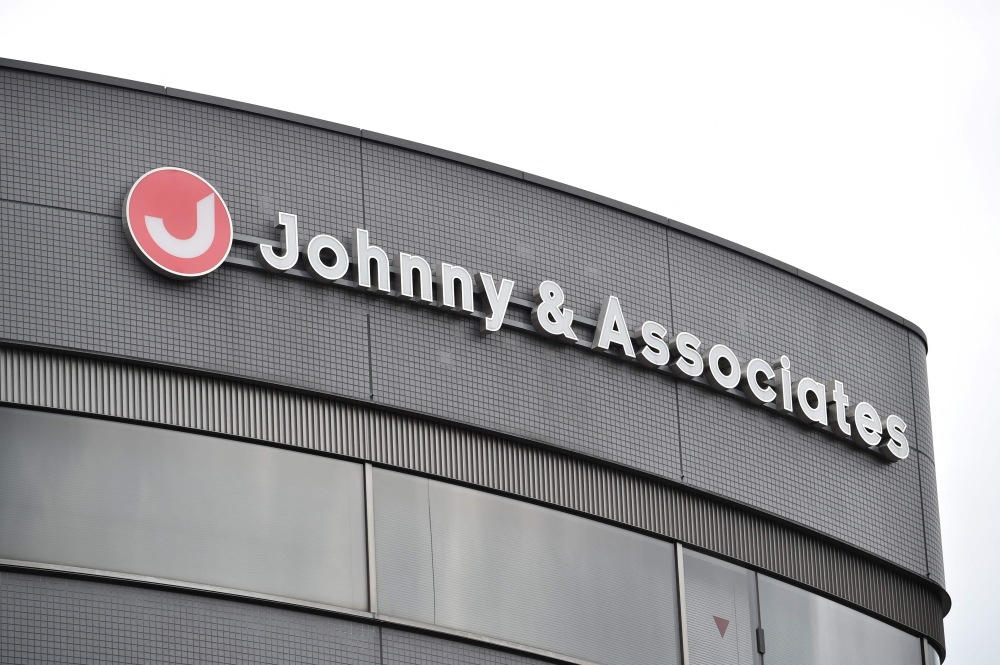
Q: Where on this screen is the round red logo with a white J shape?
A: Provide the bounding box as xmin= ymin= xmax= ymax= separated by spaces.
xmin=122 ymin=168 xmax=233 ymax=279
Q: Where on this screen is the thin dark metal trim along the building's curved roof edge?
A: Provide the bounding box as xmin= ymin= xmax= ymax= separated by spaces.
xmin=0 ymin=58 xmax=928 ymax=352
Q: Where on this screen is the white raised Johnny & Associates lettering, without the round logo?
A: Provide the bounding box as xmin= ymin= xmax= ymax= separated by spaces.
xmin=256 ymin=213 xmax=910 ymax=462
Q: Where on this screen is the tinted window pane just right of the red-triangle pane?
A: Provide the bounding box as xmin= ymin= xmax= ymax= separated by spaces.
xmin=757 ymin=575 xmax=921 ymax=665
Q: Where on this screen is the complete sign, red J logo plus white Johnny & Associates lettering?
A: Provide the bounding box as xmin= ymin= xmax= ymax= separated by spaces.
xmin=122 ymin=168 xmax=909 ymax=462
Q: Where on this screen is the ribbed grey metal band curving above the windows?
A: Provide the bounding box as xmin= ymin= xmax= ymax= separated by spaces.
xmin=0 ymin=347 xmax=944 ymax=645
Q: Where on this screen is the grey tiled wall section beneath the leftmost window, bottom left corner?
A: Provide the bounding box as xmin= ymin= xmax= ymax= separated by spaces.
xmin=0 ymin=570 xmax=382 ymax=665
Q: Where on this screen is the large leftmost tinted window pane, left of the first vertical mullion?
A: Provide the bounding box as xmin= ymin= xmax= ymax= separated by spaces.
xmin=0 ymin=408 xmax=368 ymax=609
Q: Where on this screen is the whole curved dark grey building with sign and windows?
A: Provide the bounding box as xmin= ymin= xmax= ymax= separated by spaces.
xmin=0 ymin=61 xmax=950 ymax=665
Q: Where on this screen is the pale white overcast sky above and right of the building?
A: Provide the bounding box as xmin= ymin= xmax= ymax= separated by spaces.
xmin=0 ymin=0 xmax=1000 ymax=663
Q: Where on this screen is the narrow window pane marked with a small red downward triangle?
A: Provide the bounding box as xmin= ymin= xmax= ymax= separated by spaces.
xmin=684 ymin=550 xmax=757 ymax=665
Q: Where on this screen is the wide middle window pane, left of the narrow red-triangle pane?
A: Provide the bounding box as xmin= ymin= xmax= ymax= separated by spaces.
xmin=374 ymin=472 xmax=679 ymax=665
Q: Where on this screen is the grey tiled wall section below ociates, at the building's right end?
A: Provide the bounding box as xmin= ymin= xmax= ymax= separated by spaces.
xmin=678 ymin=384 xmax=926 ymax=571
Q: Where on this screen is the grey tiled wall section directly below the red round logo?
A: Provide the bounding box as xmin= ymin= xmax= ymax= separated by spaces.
xmin=0 ymin=200 xmax=369 ymax=399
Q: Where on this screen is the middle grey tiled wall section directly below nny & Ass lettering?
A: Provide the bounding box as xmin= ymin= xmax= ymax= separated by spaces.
xmin=372 ymin=300 xmax=680 ymax=479
